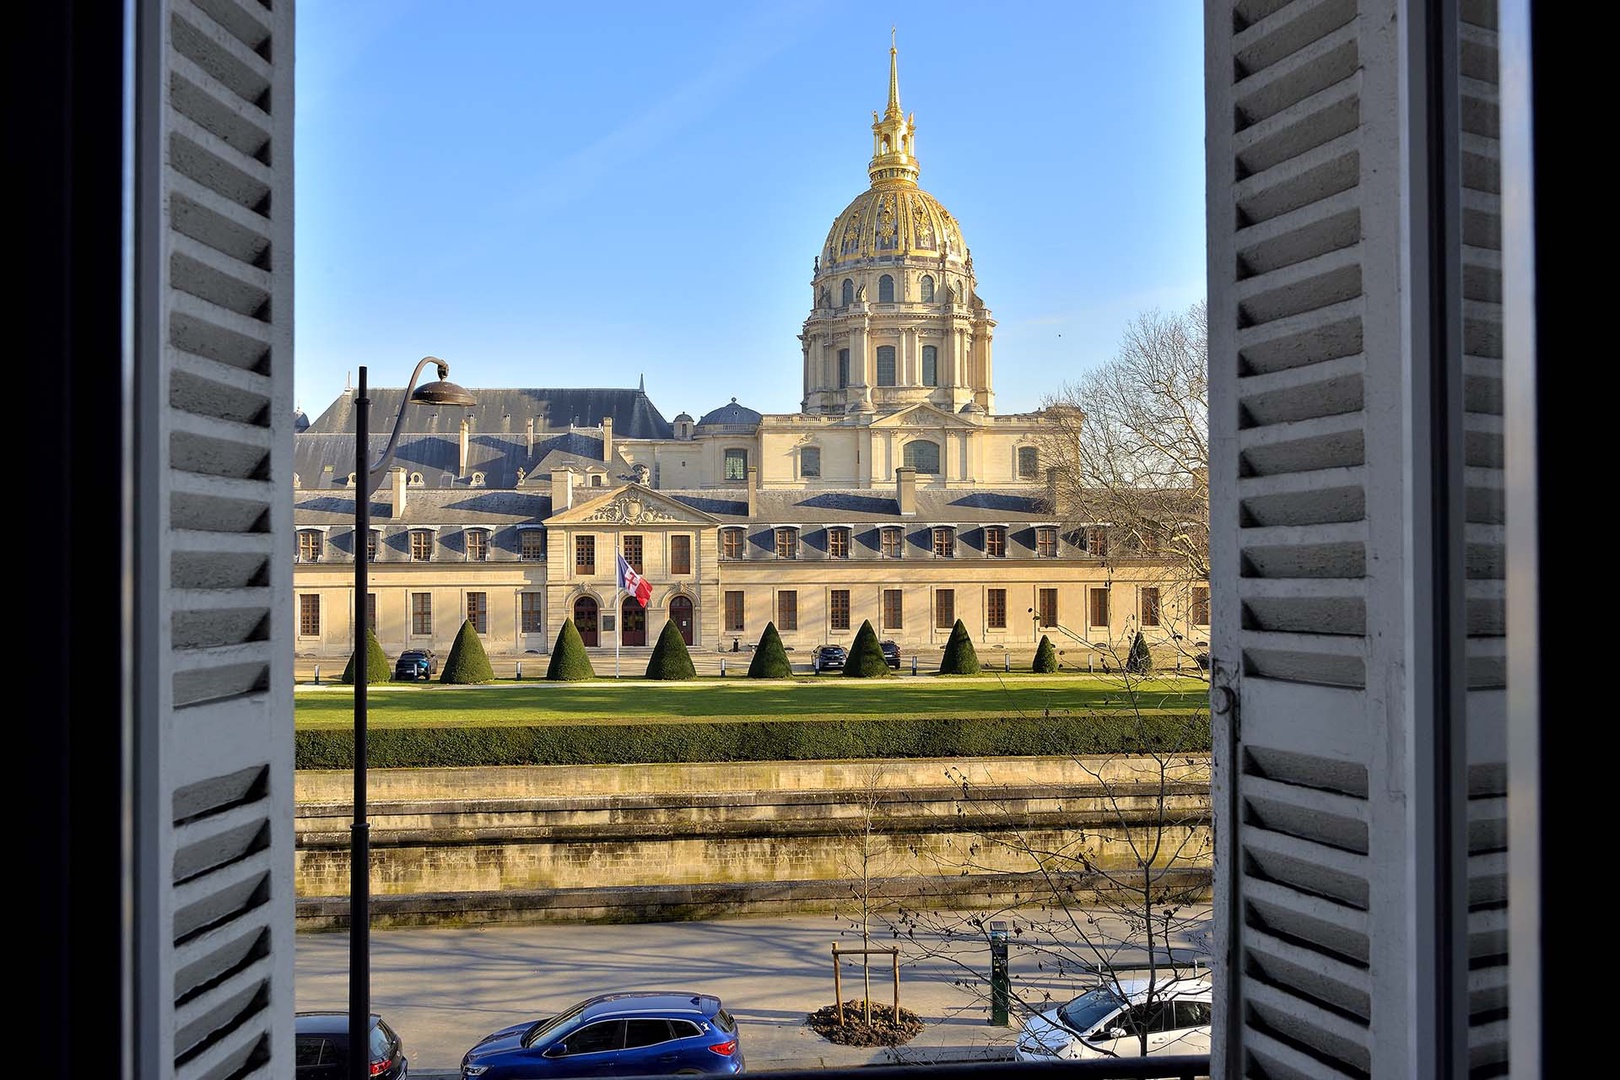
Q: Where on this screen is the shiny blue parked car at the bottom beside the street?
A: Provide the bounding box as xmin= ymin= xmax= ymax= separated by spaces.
xmin=462 ymin=991 xmax=744 ymax=1080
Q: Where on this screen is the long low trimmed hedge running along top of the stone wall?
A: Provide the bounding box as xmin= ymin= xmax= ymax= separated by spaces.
xmin=293 ymin=712 xmax=1210 ymax=769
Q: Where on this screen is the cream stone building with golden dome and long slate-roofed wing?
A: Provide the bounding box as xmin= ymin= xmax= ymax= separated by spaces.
xmin=293 ymin=45 xmax=1209 ymax=677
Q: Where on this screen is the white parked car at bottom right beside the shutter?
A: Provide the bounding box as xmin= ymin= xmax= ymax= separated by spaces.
xmin=1013 ymin=978 xmax=1213 ymax=1061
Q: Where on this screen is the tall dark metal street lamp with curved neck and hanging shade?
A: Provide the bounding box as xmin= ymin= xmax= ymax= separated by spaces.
xmin=348 ymin=356 xmax=473 ymax=1080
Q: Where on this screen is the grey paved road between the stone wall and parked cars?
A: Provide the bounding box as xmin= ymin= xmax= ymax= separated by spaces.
xmin=296 ymin=916 xmax=1211 ymax=1080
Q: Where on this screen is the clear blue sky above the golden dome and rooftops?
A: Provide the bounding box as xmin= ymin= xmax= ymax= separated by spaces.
xmin=295 ymin=0 xmax=1204 ymax=418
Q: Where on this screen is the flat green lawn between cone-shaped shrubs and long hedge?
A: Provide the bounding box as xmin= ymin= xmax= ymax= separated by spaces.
xmin=293 ymin=672 xmax=1209 ymax=730
